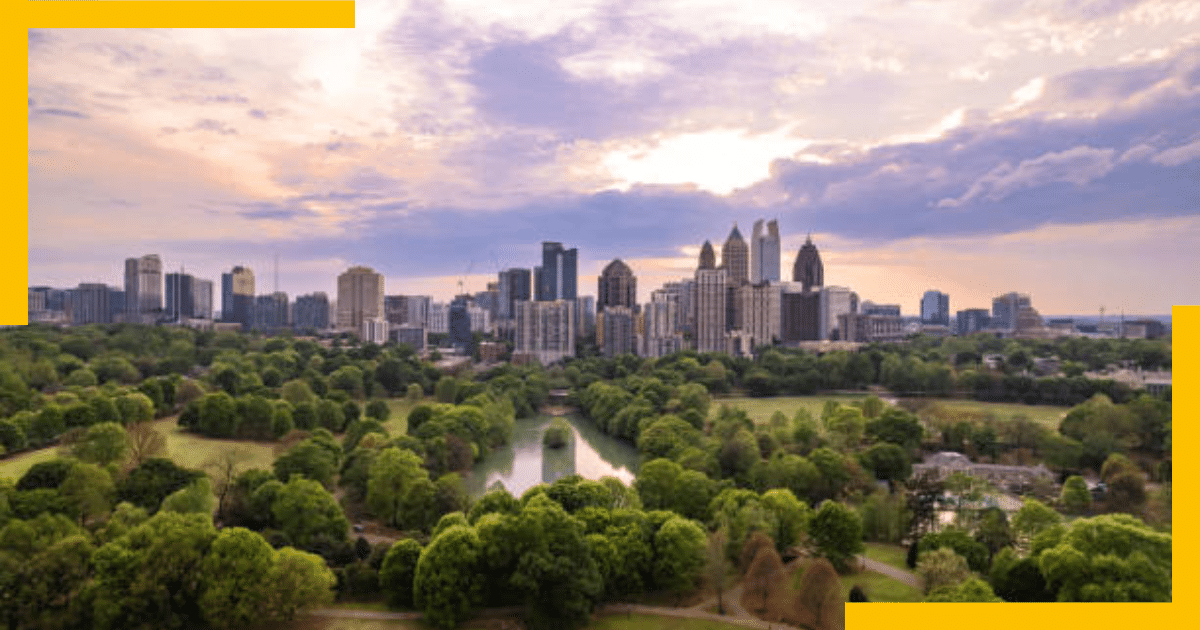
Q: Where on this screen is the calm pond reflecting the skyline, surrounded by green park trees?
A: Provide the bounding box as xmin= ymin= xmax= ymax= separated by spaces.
xmin=463 ymin=415 xmax=638 ymax=497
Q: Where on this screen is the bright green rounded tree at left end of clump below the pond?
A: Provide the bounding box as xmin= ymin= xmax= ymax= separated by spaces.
xmin=413 ymin=526 xmax=480 ymax=629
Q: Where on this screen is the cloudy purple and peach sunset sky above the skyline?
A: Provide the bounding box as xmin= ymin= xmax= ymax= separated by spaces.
xmin=29 ymin=0 xmax=1200 ymax=314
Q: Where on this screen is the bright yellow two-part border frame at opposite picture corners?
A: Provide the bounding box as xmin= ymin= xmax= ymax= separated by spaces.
xmin=11 ymin=0 xmax=1200 ymax=630
